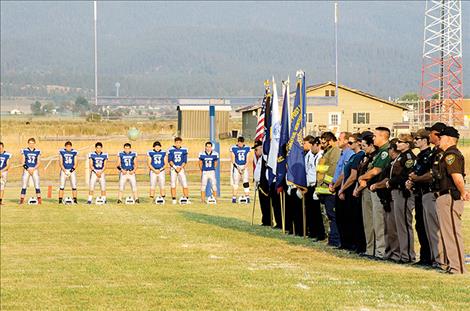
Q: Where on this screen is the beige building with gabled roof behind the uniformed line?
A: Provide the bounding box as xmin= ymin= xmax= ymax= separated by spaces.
xmin=304 ymin=82 xmax=407 ymax=134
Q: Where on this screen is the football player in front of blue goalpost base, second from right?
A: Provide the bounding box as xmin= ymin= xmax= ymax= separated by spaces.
xmin=199 ymin=141 xmax=219 ymax=203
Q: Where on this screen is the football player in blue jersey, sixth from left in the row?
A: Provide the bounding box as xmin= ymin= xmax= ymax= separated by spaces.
xmin=147 ymin=141 xmax=167 ymax=199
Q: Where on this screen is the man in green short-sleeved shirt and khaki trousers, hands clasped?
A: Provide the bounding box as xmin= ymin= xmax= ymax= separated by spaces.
xmin=358 ymin=127 xmax=391 ymax=259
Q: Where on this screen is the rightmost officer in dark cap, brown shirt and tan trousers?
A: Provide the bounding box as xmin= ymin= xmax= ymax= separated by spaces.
xmin=432 ymin=127 xmax=470 ymax=273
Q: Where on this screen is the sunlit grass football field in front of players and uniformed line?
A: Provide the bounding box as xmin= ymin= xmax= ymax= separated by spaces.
xmin=0 ymin=192 xmax=470 ymax=310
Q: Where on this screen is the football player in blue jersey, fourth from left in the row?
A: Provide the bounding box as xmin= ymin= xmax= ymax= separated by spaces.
xmin=87 ymin=142 xmax=108 ymax=204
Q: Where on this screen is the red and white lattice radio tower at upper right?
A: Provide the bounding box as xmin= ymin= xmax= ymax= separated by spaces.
xmin=418 ymin=0 xmax=463 ymax=126
